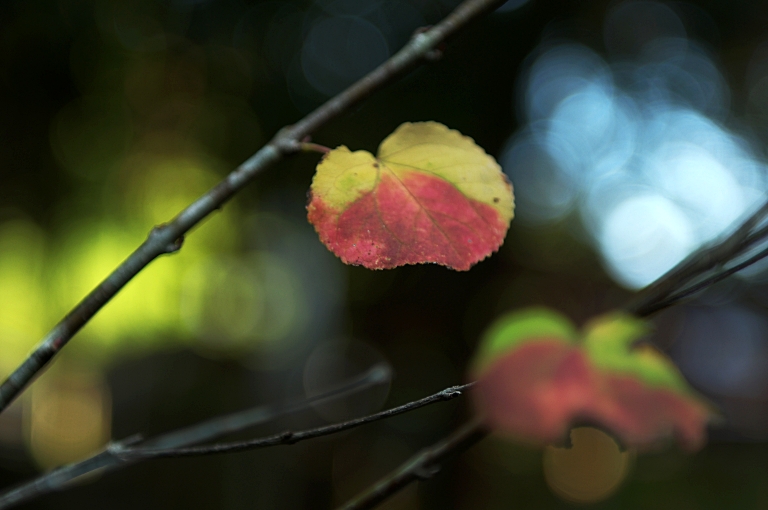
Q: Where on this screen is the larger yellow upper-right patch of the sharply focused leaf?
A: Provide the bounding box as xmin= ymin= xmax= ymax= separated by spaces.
xmin=378 ymin=122 xmax=514 ymax=222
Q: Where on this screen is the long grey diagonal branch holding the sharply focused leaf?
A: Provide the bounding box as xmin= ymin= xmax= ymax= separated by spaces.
xmin=0 ymin=0 xmax=510 ymax=412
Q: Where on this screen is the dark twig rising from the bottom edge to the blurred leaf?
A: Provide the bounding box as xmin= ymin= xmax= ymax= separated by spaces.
xmin=339 ymin=419 xmax=488 ymax=510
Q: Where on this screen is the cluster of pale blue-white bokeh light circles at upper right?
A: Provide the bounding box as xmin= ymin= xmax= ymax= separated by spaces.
xmin=500 ymin=2 xmax=766 ymax=289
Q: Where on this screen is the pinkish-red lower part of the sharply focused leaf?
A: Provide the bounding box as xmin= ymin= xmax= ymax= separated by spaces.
xmin=307 ymin=171 xmax=508 ymax=270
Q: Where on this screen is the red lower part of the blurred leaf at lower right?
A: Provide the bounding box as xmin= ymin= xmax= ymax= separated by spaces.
xmin=474 ymin=340 xmax=709 ymax=450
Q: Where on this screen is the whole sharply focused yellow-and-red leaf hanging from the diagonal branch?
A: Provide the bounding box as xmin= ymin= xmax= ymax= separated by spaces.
xmin=307 ymin=122 xmax=513 ymax=270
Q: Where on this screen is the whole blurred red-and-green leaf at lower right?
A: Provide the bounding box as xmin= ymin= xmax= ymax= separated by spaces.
xmin=472 ymin=308 xmax=712 ymax=450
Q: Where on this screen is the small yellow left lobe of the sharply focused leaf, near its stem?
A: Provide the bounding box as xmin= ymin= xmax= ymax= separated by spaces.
xmin=312 ymin=145 xmax=379 ymax=210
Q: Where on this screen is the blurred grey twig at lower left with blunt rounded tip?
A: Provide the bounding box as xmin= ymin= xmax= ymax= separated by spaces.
xmin=0 ymin=365 xmax=402 ymax=509
